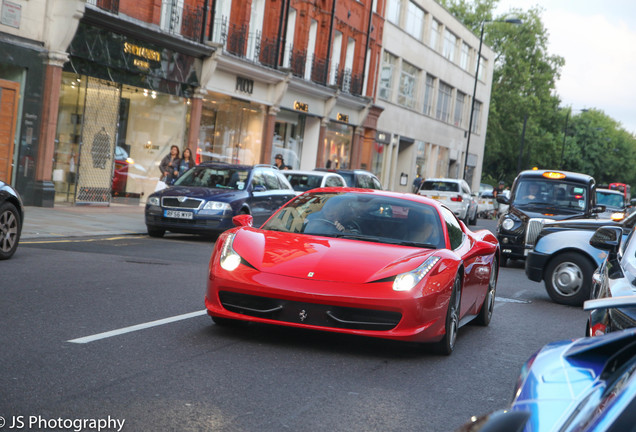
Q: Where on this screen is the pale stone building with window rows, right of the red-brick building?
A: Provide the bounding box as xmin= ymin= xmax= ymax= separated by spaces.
xmin=376 ymin=0 xmax=494 ymax=191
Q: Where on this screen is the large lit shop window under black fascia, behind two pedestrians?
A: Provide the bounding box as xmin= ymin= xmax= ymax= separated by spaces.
xmin=53 ymin=72 xmax=190 ymax=204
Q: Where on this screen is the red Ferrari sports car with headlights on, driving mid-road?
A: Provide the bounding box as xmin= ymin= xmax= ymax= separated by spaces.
xmin=205 ymin=188 xmax=499 ymax=354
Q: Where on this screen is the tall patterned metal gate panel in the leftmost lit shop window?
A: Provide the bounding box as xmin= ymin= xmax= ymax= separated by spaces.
xmin=75 ymin=77 xmax=121 ymax=205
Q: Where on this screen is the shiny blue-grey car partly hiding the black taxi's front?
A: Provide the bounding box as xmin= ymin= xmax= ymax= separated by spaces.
xmin=525 ymin=213 xmax=636 ymax=306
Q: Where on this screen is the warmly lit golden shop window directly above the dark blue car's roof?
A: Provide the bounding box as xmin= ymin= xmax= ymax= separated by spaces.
xmin=197 ymin=96 xmax=265 ymax=165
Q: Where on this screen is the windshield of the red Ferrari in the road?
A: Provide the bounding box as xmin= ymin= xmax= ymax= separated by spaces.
xmin=262 ymin=192 xmax=445 ymax=248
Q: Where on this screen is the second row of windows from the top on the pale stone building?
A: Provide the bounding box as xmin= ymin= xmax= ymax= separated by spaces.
xmin=378 ymin=51 xmax=481 ymax=133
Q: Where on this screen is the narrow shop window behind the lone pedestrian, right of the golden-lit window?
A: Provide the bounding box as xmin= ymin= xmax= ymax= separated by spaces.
xmin=271 ymin=111 xmax=305 ymax=169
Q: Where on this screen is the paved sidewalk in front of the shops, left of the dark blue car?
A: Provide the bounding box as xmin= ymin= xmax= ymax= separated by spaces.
xmin=20 ymin=204 xmax=147 ymax=240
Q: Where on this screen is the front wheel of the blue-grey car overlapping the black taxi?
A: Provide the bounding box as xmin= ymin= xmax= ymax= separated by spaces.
xmin=543 ymin=252 xmax=594 ymax=306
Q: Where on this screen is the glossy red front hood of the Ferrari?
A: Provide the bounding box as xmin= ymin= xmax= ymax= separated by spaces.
xmin=232 ymin=228 xmax=435 ymax=283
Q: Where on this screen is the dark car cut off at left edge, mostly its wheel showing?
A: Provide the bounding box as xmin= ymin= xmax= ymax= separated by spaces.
xmin=0 ymin=180 xmax=24 ymax=260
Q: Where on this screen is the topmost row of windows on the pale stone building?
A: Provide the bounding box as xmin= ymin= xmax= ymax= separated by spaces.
xmin=386 ymin=0 xmax=486 ymax=80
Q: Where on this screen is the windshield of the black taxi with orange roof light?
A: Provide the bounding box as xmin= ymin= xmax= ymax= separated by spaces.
xmin=513 ymin=178 xmax=588 ymax=211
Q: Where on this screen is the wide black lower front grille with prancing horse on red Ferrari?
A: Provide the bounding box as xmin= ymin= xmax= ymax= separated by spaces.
xmin=219 ymin=291 xmax=402 ymax=331
